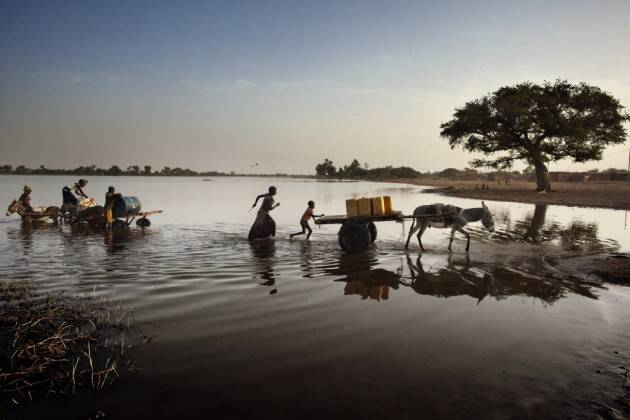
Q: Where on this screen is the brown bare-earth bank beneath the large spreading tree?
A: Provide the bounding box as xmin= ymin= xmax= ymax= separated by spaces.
xmin=384 ymin=179 xmax=630 ymax=210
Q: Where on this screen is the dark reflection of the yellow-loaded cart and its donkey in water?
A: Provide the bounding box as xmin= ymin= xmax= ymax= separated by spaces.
xmin=327 ymin=254 xmax=602 ymax=304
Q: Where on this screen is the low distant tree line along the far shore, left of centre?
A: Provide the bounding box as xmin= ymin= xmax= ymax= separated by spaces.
xmin=0 ymin=165 xmax=306 ymax=177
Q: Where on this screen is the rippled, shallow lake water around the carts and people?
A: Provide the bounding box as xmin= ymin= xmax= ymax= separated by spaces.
xmin=0 ymin=176 xmax=630 ymax=418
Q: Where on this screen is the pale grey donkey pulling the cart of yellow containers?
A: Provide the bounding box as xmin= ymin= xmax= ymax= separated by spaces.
xmin=405 ymin=201 xmax=494 ymax=252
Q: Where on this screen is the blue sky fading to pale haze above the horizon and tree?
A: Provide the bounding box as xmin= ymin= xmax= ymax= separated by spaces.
xmin=0 ymin=0 xmax=630 ymax=174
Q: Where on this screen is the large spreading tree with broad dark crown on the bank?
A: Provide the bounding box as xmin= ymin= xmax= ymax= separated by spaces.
xmin=440 ymin=80 xmax=630 ymax=191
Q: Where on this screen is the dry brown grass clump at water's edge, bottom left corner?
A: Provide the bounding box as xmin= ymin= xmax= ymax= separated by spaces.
xmin=0 ymin=278 xmax=146 ymax=404
